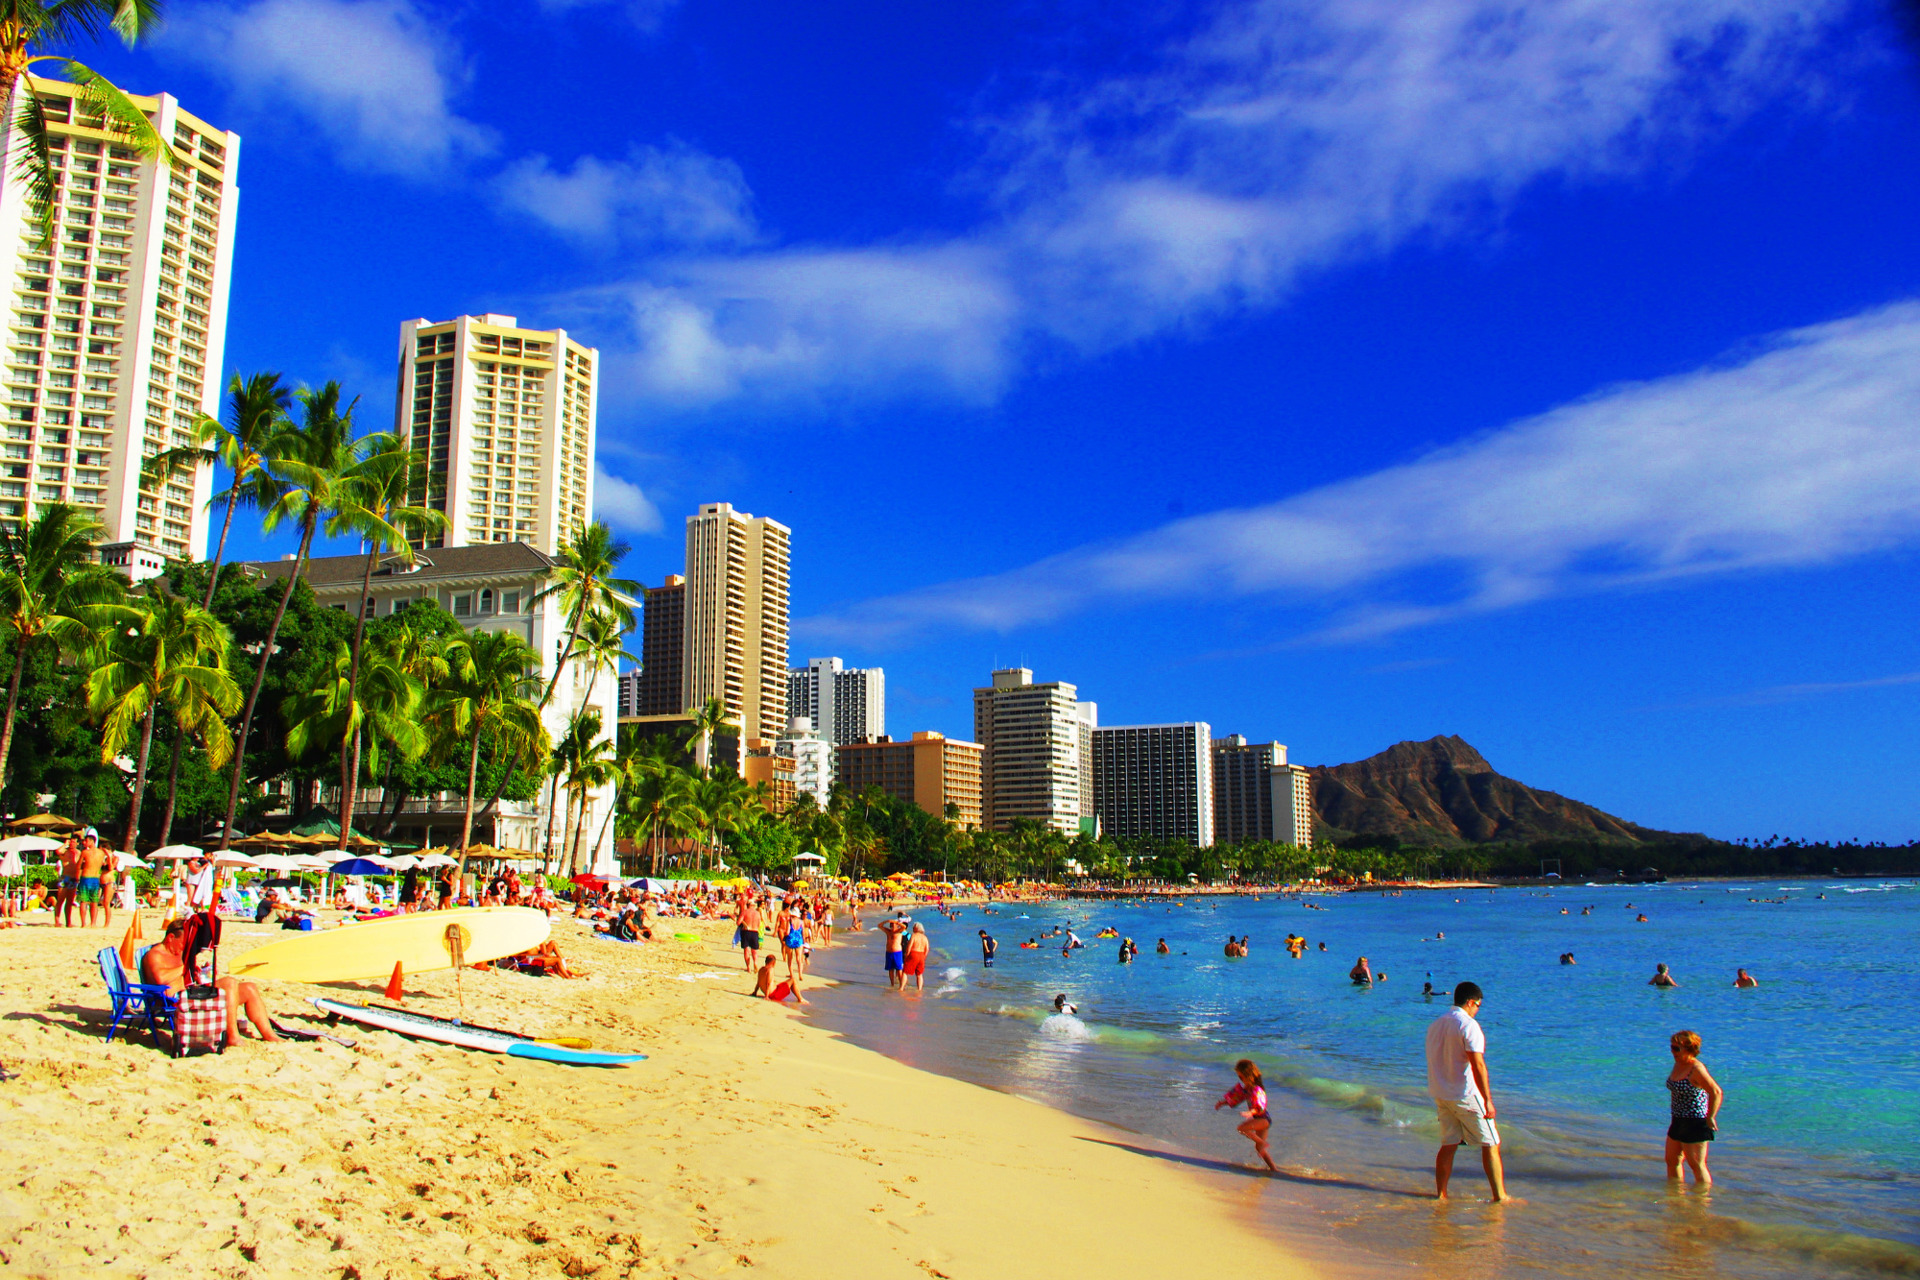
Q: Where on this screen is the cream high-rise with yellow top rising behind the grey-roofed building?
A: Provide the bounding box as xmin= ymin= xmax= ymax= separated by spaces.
xmin=394 ymin=315 xmax=599 ymax=555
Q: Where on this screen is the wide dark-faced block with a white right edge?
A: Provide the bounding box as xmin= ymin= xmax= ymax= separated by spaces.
xmin=1092 ymin=722 xmax=1213 ymax=848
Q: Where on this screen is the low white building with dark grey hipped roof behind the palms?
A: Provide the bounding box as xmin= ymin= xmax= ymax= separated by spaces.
xmin=248 ymin=541 xmax=618 ymax=875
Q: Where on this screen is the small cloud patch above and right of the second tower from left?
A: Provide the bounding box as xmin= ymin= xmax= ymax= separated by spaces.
xmin=499 ymin=146 xmax=755 ymax=246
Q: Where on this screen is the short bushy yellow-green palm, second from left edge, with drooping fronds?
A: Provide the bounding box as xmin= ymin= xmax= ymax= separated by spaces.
xmin=86 ymin=583 xmax=240 ymax=852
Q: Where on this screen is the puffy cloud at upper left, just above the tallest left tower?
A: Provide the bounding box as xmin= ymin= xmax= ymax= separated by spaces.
xmin=165 ymin=0 xmax=493 ymax=173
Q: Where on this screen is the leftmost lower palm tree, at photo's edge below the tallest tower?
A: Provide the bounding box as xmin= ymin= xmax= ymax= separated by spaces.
xmin=0 ymin=503 xmax=125 ymax=785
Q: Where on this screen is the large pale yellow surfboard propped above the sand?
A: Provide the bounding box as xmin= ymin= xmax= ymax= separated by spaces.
xmin=230 ymin=906 xmax=553 ymax=983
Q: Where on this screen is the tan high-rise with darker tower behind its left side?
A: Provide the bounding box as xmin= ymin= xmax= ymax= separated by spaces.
xmin=680 ymin=503 xmax=791 ymax=741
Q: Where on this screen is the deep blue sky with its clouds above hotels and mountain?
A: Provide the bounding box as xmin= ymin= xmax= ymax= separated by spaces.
xmin=74 ymin=0 xmax=1920 ymax=841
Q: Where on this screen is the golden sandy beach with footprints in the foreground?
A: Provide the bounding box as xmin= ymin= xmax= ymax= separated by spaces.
xmin=0 ymin=913 xmax=1306 ymax=1280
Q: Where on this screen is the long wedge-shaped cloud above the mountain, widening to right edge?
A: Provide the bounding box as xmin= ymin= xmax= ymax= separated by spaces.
xmin=803 ymin=301 xmax=1920 ymax=643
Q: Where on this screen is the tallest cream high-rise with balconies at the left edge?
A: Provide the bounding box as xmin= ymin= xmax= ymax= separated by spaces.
xmin=0 ymin=77 xmax=240 ymax=564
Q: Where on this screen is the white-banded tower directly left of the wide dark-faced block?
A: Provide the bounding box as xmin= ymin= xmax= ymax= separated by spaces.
xmin=973 ymin=666 xmax=1094 ymax=835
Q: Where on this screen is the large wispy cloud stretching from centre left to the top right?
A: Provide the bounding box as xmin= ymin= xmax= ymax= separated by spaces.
xmin=587 ymin=0 xmax=1847 ymax=399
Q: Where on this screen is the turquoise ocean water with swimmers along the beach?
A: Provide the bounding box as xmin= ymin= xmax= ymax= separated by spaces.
xmin=812 ymin=881 xmax=1920 ymax=1276
